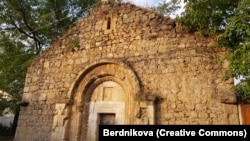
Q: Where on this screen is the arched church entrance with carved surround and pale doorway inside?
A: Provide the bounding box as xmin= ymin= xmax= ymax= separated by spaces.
xmin=66 ymin=60 xmax=140 ymax=141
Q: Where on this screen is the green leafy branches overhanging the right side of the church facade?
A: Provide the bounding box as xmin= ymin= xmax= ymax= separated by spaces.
xmin=178 ymin=0 xmax=250 ymax=101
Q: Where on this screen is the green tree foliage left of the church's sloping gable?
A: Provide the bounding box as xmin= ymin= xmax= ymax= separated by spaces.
xmin=0 ymin=0 xmax=100 ymax=134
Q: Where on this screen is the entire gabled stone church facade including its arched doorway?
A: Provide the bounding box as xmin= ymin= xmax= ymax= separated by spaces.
xmin=15 ymin=2 xmax=239 ymax=141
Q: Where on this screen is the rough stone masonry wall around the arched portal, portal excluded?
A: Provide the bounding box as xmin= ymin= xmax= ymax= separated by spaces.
xmin=15 ymin=3 xmax=238 ymax=141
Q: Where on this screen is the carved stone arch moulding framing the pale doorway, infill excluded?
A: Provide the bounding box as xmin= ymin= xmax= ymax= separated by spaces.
xmin=68 ymin=59 xmax=140 ymax=140
